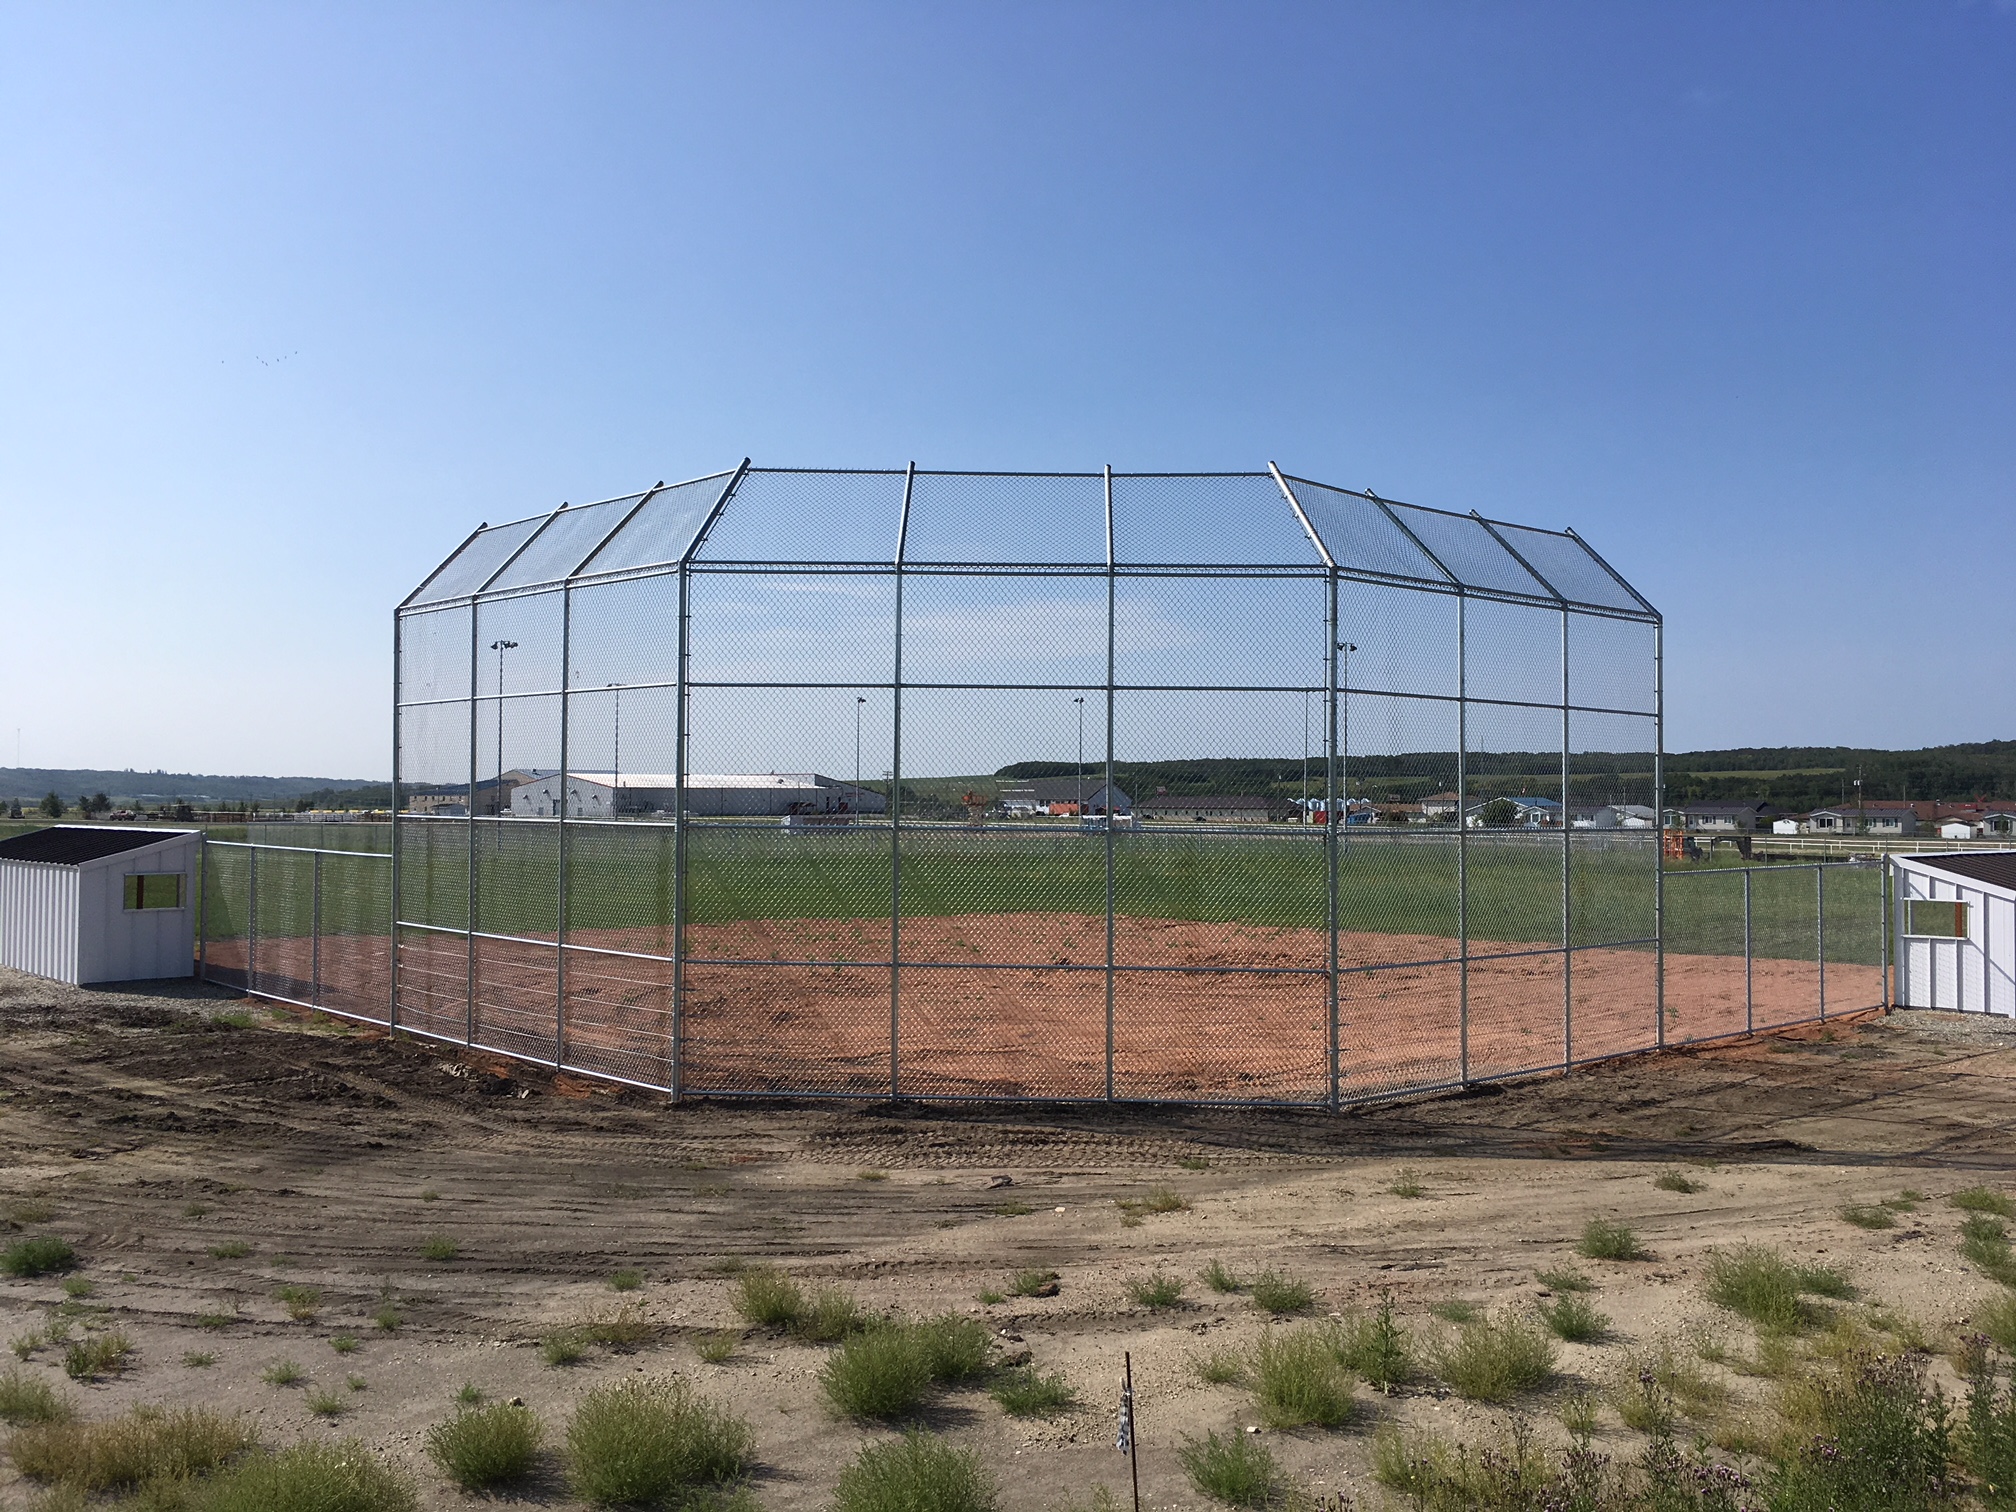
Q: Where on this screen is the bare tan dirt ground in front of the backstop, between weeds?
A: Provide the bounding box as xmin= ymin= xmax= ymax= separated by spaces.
xmin=0 ymin=970 xmax=2016 ymax=1512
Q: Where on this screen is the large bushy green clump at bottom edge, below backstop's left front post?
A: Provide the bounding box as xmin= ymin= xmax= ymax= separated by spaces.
xmin=566 ymin=1377 xmax=756 ymax=1506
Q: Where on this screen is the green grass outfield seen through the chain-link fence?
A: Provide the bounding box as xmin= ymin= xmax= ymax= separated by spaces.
xmin=192 ymin=821 xmax=1883 ymax=964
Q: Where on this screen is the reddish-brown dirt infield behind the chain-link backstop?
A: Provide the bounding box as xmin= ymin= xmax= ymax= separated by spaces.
xmin=196 ymin=913 xmax=1881 ymax=1103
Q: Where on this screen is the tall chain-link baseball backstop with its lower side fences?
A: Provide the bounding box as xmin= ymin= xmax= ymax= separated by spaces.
xmin=189 ymin=466 xmax=1883 ymax=1103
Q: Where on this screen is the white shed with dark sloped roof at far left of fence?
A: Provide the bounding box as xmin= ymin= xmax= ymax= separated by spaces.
xmin=0 ymin=825 xmax=204 ymax=984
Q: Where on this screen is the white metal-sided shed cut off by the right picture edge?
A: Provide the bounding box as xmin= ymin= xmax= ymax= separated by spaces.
xmin=1891 ymin=851 xmax=2016 ymax=1018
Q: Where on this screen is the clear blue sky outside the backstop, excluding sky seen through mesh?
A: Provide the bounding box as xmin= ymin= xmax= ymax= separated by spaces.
xmin=0 ymin=0 xmax=2016 ymax=776
